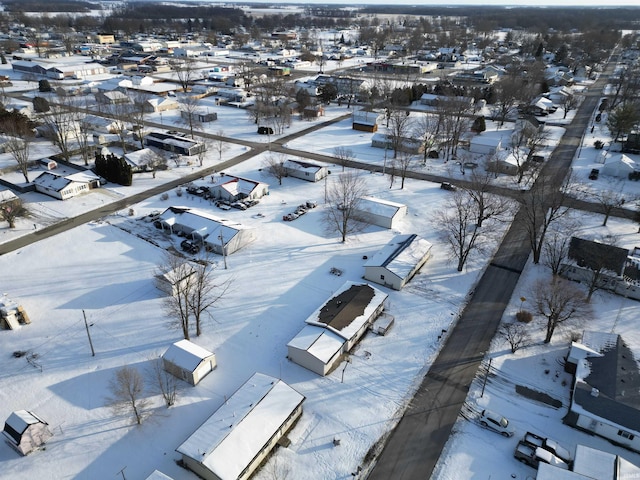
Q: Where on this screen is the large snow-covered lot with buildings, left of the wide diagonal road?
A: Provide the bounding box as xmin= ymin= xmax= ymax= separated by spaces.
xmin=0 ymin=152 xmax=510 ymax=479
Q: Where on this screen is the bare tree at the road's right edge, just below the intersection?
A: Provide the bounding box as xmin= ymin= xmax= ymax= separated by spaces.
xmin=518 ymin=176 xmax=571 ymax=264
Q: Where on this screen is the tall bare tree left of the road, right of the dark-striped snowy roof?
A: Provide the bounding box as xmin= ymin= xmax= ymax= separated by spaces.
xmin=435 ymin=190 xmax=483 ymax=272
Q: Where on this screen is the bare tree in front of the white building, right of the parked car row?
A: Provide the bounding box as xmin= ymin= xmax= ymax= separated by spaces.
xmin=324 ymin=171 xmax=366 ymax=243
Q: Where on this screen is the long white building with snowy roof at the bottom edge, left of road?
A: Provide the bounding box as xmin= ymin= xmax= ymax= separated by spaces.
xmin=176 ymin=373 xmax=305 ymax=480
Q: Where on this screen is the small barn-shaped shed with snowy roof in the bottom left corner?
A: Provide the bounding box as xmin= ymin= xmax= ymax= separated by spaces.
xmin=2 ymin=410 xmax=53 ymax=455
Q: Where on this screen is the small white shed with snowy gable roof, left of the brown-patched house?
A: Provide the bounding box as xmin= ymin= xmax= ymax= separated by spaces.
xmin=162 ymin=340 xmax=216 ymax=385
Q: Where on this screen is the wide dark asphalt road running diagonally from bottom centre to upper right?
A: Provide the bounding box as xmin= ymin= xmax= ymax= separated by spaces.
xmin=367 ymin=54 xmax=612 ymax=480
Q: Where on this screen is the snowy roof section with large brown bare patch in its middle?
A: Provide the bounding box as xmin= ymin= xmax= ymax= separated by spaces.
xmin=306 ymin=282 xmax=388 ymax=340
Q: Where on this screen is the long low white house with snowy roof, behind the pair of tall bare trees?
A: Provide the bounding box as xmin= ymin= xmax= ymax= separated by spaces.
xmin=158 ymin=207 xmax=256 ymax=255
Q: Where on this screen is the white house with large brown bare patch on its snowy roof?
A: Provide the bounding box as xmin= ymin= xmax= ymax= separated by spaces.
xmin=287 ymin=282 xmax=388 ymax=376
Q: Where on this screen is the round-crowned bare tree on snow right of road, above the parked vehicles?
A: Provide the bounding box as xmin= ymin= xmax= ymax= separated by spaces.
xmin=531 ymin=277 xmax=590 ymax=343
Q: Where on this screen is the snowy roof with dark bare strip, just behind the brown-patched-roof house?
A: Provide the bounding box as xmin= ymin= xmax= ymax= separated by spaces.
xmin=364 ymin=234 xmax=433 ymax=278
